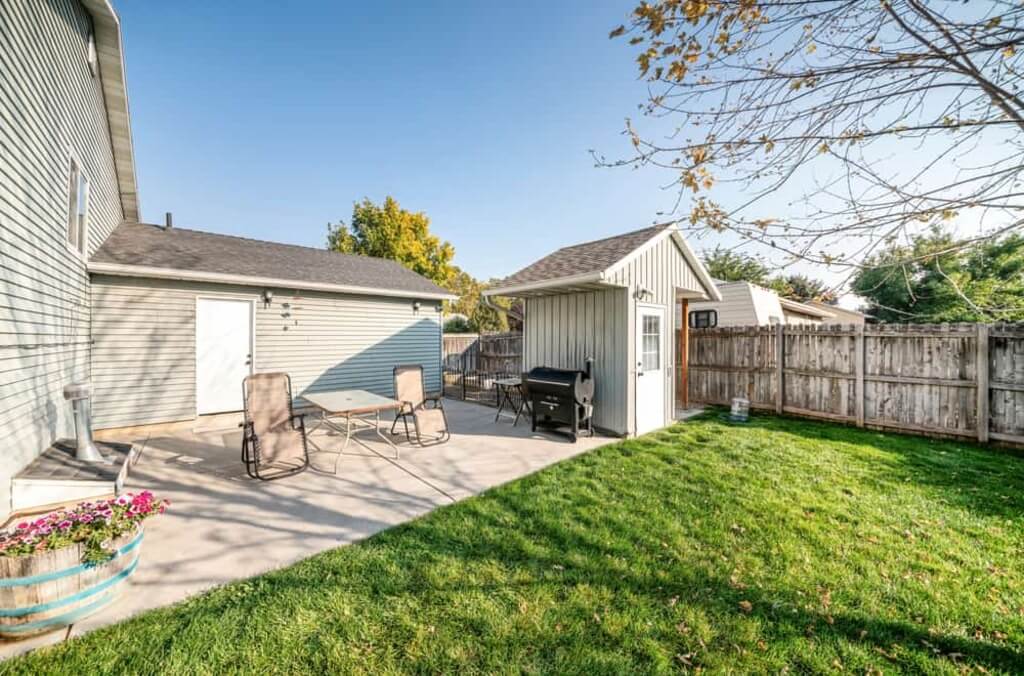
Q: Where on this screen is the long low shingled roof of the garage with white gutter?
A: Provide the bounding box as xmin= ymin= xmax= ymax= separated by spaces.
xmin=89 ymin=222 xmax=456 ymax=300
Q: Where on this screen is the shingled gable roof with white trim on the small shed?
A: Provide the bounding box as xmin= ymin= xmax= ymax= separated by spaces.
xmin=483 ymin=223 xmax=718 ymax=297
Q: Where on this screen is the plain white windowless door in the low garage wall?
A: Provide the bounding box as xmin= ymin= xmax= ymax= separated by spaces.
xmin=196 ymin=298 xmax=253 ymax=415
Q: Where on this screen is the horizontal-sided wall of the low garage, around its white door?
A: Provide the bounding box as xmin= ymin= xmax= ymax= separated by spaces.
xmin=92 ymin=276 xmax=441 ymax=428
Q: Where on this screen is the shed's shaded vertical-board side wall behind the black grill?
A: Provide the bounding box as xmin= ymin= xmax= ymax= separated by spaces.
xmin=523 ymin=289 xmax=629 ymax=434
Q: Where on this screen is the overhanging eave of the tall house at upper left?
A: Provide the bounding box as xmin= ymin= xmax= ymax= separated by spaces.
xmin=82 ymin=0 xmax=139 ymax=221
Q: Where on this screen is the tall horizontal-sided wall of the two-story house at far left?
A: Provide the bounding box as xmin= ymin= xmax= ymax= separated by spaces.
xmin=0 ymin=0 xmax=122 ymax=514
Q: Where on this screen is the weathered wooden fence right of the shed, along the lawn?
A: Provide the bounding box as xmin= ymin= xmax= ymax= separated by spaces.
xmin=688 ymin=324 xmax=1024 ymax=445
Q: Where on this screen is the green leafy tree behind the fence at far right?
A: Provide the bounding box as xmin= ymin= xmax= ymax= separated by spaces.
xmin=852 ymin=228 xmax=1024 ymax=322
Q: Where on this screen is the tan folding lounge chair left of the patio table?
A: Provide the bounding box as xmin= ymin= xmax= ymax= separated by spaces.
xmin=242 ymin=373 xmax=309 ymax=481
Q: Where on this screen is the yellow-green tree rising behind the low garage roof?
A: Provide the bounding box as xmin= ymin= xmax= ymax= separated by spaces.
xmin=327 ymin=196 xmax=456 ymax=287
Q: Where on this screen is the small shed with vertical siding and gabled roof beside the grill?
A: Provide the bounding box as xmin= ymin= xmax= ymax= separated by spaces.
xmin=484 ymin=225 xmax=720 ymax=435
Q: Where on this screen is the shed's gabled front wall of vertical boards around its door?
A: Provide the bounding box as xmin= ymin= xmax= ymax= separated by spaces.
xmin=608 ymin=237 xmax=706 ymax=432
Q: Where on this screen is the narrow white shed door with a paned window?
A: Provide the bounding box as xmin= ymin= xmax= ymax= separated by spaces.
xmin=636 ymin=305 xmax=667 ymax=434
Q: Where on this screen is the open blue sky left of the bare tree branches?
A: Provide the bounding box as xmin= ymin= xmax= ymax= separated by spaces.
xmin=118 ymin=0 xmax=675 ymax=279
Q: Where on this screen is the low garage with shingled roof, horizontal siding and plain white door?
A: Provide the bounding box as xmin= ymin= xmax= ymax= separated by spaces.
xmin=89 ymin=223 xmax=454 ymax=428
